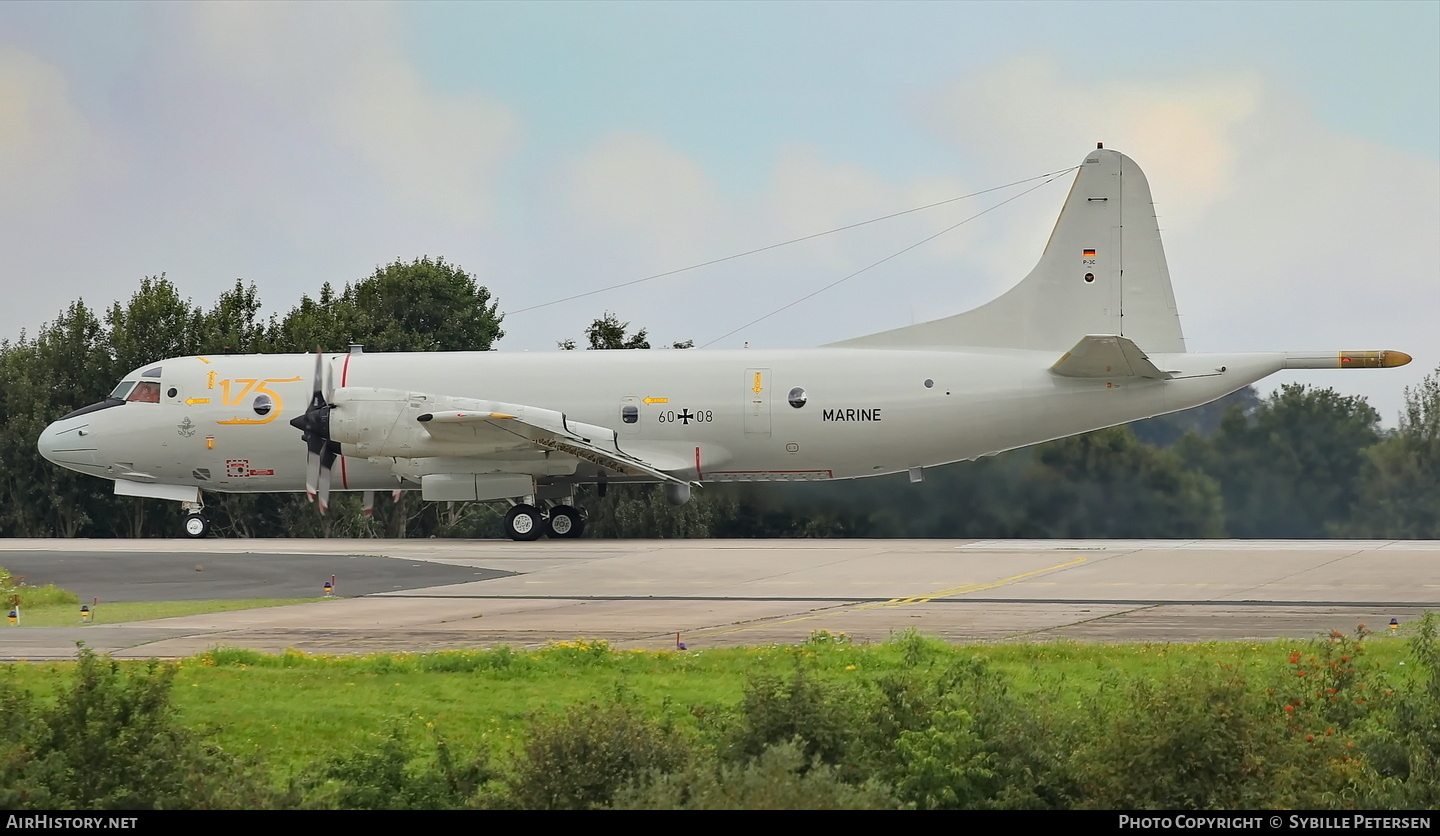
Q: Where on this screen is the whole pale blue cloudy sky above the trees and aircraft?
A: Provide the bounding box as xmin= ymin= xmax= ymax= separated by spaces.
xmin=0 ymin=0 xmax=1440 ymax=427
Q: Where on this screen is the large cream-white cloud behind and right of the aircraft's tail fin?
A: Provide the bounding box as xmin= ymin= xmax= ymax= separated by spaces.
xmin=927 ymin=59 xmax=1440 ymax=420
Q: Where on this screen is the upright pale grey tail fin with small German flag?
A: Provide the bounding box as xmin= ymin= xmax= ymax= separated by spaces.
xmin=831 ymin=150 xmax=1185 ymax=353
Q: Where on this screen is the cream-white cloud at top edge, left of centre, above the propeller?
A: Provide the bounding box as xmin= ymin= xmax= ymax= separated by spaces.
xmin=189 ymin=3 xmax=520 ymax=224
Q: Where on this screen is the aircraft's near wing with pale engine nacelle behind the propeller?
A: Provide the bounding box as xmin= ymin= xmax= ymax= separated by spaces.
xmin=330 ymin=387 xmax=691 ymax=485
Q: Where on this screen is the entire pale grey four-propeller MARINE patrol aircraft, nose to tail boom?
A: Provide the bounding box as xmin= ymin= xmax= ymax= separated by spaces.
xmin=39 ymin=150 xmax=1410 ymax=540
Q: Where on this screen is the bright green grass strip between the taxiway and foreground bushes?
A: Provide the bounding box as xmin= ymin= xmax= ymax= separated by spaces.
xmin=3 ymin=635 xmax=1405 ymax=771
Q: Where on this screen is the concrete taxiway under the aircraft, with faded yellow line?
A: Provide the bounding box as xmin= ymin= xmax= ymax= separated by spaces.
xmin=0 ymin=540 xmax=1440 ymax=659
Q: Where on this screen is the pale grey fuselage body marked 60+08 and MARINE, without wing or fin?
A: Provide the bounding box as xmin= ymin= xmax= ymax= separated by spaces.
xmin=40 ymin=348 xmax=1307 ymax=492
